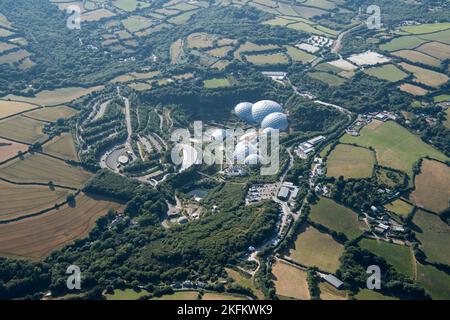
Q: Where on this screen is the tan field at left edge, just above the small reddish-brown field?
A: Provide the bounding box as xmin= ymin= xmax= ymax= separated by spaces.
xmin=0 ymin=116 xmax=48 ymax=144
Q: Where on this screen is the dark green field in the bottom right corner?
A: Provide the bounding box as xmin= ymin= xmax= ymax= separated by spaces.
xmin=417 ymin=263 xmax=450 ymax=300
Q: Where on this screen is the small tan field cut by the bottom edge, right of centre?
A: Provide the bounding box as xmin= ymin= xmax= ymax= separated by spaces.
xmin=272 ymin=260 xmax=311 ymax=300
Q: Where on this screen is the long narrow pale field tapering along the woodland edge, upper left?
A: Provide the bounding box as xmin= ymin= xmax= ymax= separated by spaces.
xmin=3 ymin=86 xmax=104 ymax=106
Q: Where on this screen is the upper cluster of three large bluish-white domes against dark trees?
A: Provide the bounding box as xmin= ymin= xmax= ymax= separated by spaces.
xmin=234 ymin=100 xmax=289 ymax=131
